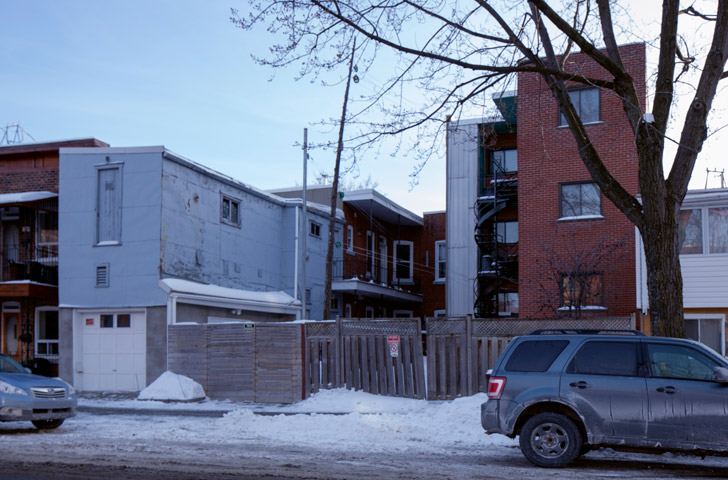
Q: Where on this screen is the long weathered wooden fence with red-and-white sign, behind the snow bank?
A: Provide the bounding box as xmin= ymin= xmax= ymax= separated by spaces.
xmin=167 ymin=317 xmax=634 ymax=403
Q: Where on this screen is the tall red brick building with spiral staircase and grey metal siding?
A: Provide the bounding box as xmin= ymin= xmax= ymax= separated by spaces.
xmin=447 ymin=44 xmax=646 ymax=318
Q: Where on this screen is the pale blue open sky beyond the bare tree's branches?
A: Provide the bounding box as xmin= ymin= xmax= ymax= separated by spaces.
xmin=0 ymin=0 xmax=723 ymax=218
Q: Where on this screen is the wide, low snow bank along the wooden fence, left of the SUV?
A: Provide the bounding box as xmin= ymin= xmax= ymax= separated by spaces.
xmin=213 ymin=389 xmax=517 ymax=453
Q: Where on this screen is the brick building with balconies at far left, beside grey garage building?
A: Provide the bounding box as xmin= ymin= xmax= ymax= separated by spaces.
xmin=0 ymin=138 xmax=108 ymax=374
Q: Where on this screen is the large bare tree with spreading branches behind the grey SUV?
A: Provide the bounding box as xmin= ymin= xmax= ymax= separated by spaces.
xmin=232 ymin=0 xmax=728 ymax=336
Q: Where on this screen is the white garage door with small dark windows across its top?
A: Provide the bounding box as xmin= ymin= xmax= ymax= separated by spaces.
xmin=76 ymin=313 xmax=147 ymax=392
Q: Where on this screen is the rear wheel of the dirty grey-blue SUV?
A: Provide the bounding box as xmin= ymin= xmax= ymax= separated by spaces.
xmin=519 ymin=413 xmax=582 ymax=468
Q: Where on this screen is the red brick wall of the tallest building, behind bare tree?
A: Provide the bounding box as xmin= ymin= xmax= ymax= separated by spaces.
xmin=518 ymin=44 xmax=646 ymax=318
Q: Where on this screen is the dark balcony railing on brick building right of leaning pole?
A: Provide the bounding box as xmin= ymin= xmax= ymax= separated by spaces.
xmin=332 ymin=255 xmax=422 ymax=293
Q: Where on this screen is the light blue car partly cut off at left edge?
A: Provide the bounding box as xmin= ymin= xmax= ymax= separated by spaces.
xmin=0 ymin=353 xmax=78 ymax=429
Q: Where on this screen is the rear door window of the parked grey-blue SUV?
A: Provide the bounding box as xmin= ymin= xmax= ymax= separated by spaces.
xmin=567 ymin=342 xmax=637 ymax=377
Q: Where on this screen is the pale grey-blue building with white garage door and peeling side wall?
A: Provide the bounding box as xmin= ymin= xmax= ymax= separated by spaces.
xmin=58 ymin=147 xmax=343 ymax=391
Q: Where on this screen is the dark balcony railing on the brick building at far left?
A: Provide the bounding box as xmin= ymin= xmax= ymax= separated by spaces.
xmin=0 ymin=246 xmax=58 ymax=285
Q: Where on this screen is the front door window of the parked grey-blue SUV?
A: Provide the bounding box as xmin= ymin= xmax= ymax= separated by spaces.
xmin=647 ymin=343 xmax=721 ymax=380
